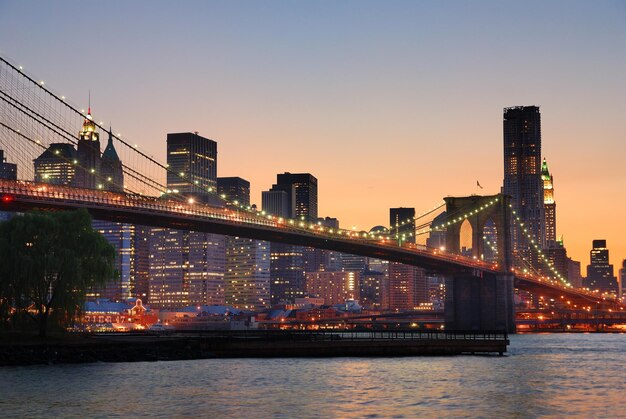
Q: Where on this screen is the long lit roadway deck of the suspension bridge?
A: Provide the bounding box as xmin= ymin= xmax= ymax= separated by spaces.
xmin=0 ymin=180 xmax=621 ymax=309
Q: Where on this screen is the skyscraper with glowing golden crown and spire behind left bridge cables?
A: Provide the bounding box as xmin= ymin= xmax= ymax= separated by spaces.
xmin=73 ymin=107 xmax=101 ymax=189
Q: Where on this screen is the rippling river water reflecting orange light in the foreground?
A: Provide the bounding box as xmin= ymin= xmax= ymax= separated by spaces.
xmin=0 ymin=334 xmax=626 ymax=418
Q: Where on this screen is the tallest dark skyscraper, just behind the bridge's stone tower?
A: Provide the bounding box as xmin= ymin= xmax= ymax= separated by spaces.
xmin=502 ymin=106 xmax=545 ymax=267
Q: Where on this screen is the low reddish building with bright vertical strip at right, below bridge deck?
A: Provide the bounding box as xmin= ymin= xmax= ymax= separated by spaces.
xmin=306 ymin=272 xmax=359 ymax=305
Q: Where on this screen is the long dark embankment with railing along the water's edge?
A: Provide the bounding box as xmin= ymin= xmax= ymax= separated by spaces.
xmin=0 ymin=331 xmax=509 ymax=366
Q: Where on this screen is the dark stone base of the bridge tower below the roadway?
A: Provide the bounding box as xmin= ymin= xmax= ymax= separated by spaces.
xmin=445 ymin=272 xmax=515 ymax=333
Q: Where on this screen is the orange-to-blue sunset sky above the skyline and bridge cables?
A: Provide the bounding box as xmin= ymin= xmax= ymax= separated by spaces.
xmin=0 ymin=0 xmax=626 ymax=275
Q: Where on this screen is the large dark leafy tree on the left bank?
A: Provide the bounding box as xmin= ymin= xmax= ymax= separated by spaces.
xmin=0 ymin=210 xmax=117 ymax=336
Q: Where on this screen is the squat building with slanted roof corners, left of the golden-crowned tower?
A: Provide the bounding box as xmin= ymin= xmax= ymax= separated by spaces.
xmin=33 ymin=143 xmax=78 ymax=186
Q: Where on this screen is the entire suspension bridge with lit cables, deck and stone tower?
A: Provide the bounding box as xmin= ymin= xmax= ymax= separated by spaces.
xmin=0 ymin=57 xmax=624 ymax=331
